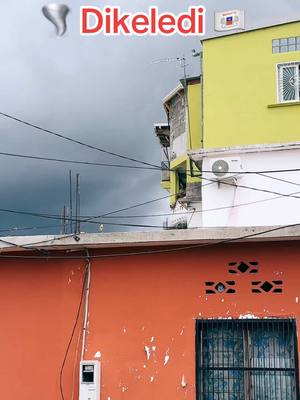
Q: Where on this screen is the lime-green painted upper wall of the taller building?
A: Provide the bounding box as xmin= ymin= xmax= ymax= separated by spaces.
xmin=203 ymin=22 xmax=300 ymax=148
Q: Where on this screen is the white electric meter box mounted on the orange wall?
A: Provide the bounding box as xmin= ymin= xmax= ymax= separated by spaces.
xmin=79 ymin=360 xmax=100 ymax=400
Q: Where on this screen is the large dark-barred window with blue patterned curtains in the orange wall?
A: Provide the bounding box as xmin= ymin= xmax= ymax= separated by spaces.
xmin=196 ymin=319 xmax=299 ymax=400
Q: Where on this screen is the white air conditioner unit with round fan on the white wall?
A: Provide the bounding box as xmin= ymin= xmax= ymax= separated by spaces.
xmin=206 ymin=157 xmax=243 ymax=182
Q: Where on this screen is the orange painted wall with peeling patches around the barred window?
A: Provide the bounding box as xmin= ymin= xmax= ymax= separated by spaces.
xmin=0 ymin=242 xmax=300 ymax=400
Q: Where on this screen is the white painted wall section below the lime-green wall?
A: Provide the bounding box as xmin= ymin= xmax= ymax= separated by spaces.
xmin=189 ymin=149 xmax=300 ymax=228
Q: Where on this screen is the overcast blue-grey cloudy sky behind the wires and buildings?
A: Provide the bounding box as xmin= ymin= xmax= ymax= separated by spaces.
xmin=0 ymin=0 xmax=300 ymax=234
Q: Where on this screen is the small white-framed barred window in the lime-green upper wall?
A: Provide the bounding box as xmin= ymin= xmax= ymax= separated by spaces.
xmin=278 ymin=62 xmax=300 ymax=103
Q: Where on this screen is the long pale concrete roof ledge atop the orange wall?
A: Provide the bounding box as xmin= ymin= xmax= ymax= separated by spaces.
xmin=0 ymin=226 xmax=300 ymax=253
